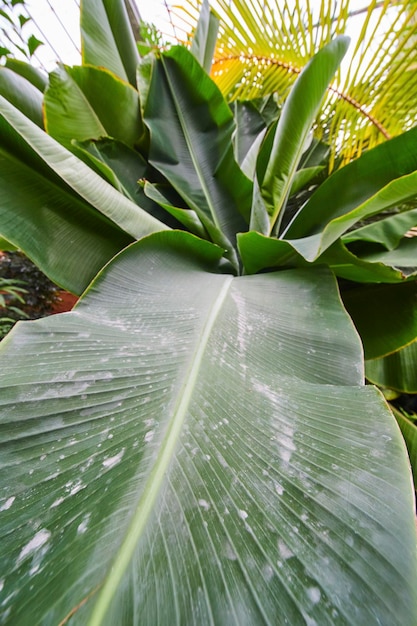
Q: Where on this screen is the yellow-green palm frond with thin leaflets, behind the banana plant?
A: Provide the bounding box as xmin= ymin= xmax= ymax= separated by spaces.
xmin=171 ymin=0 xmax=417 ymax=164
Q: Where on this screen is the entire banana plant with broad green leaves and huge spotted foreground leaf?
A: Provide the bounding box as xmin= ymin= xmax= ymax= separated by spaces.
xmin=0 ymin=0 xmax=417 ymax=626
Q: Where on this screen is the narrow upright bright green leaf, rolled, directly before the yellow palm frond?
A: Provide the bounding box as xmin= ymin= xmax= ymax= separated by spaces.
xmin=259 ymin=36 xmax=350 ymax=234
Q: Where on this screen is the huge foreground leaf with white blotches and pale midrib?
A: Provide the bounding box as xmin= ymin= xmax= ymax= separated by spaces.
xmin=0 ymin=232 xmax=417 ymax=626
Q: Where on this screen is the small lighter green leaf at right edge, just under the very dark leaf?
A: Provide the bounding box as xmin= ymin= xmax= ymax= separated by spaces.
xmin=365 ymin=341 xmax=417 ymax=393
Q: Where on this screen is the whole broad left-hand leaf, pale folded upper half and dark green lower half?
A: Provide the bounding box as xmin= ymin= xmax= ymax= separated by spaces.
xmin=0 ymin=96 xmax=168 ymax=293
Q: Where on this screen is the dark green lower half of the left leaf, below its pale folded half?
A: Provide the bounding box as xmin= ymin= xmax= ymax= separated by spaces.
xmin=0 ymin=136 xmax=132 ymax=294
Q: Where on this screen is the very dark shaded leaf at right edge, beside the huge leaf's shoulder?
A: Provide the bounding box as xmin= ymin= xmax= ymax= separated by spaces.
xmin=343 ymin=281 xmax=417 ymax=359
